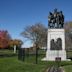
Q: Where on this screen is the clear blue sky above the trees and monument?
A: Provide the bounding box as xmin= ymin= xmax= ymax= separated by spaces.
xmin=0 ymin=0 xmax=72 ymax=46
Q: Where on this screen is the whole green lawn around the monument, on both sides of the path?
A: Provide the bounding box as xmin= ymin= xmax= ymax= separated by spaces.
xmin=0 ymin=51 xmax=72 ymax=72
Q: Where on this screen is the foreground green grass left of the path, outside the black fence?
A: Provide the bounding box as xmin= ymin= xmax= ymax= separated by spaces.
xmin=0 ymin=57 xmax=51 ymax=72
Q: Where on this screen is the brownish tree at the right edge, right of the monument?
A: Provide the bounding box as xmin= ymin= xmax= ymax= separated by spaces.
xmin=65 ymin=22 xmax=72 ymax=49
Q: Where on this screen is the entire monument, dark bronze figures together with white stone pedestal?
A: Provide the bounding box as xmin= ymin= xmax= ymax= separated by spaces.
xmin=42 ymin=9 xmax=66 ymax=61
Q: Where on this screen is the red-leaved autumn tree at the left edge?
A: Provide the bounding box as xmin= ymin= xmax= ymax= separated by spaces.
xmin=0 ymin=30 xmax=11 ymax=48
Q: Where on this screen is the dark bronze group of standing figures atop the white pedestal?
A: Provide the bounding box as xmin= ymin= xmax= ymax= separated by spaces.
xmin=48 ymin=9 xmax=64 ymax=28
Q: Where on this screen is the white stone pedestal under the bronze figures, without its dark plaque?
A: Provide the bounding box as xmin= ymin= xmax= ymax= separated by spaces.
xmin=42 ymin=29 xmax=66 ymax=61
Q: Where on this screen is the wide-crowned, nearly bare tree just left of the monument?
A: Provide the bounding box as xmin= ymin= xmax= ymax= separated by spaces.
xmin=21 ymin=23 xmax=47 ymax=47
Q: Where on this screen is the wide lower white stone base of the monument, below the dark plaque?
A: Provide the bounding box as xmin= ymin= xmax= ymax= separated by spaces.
xmin=42 ymin=50 xmax=67 ymax=61
